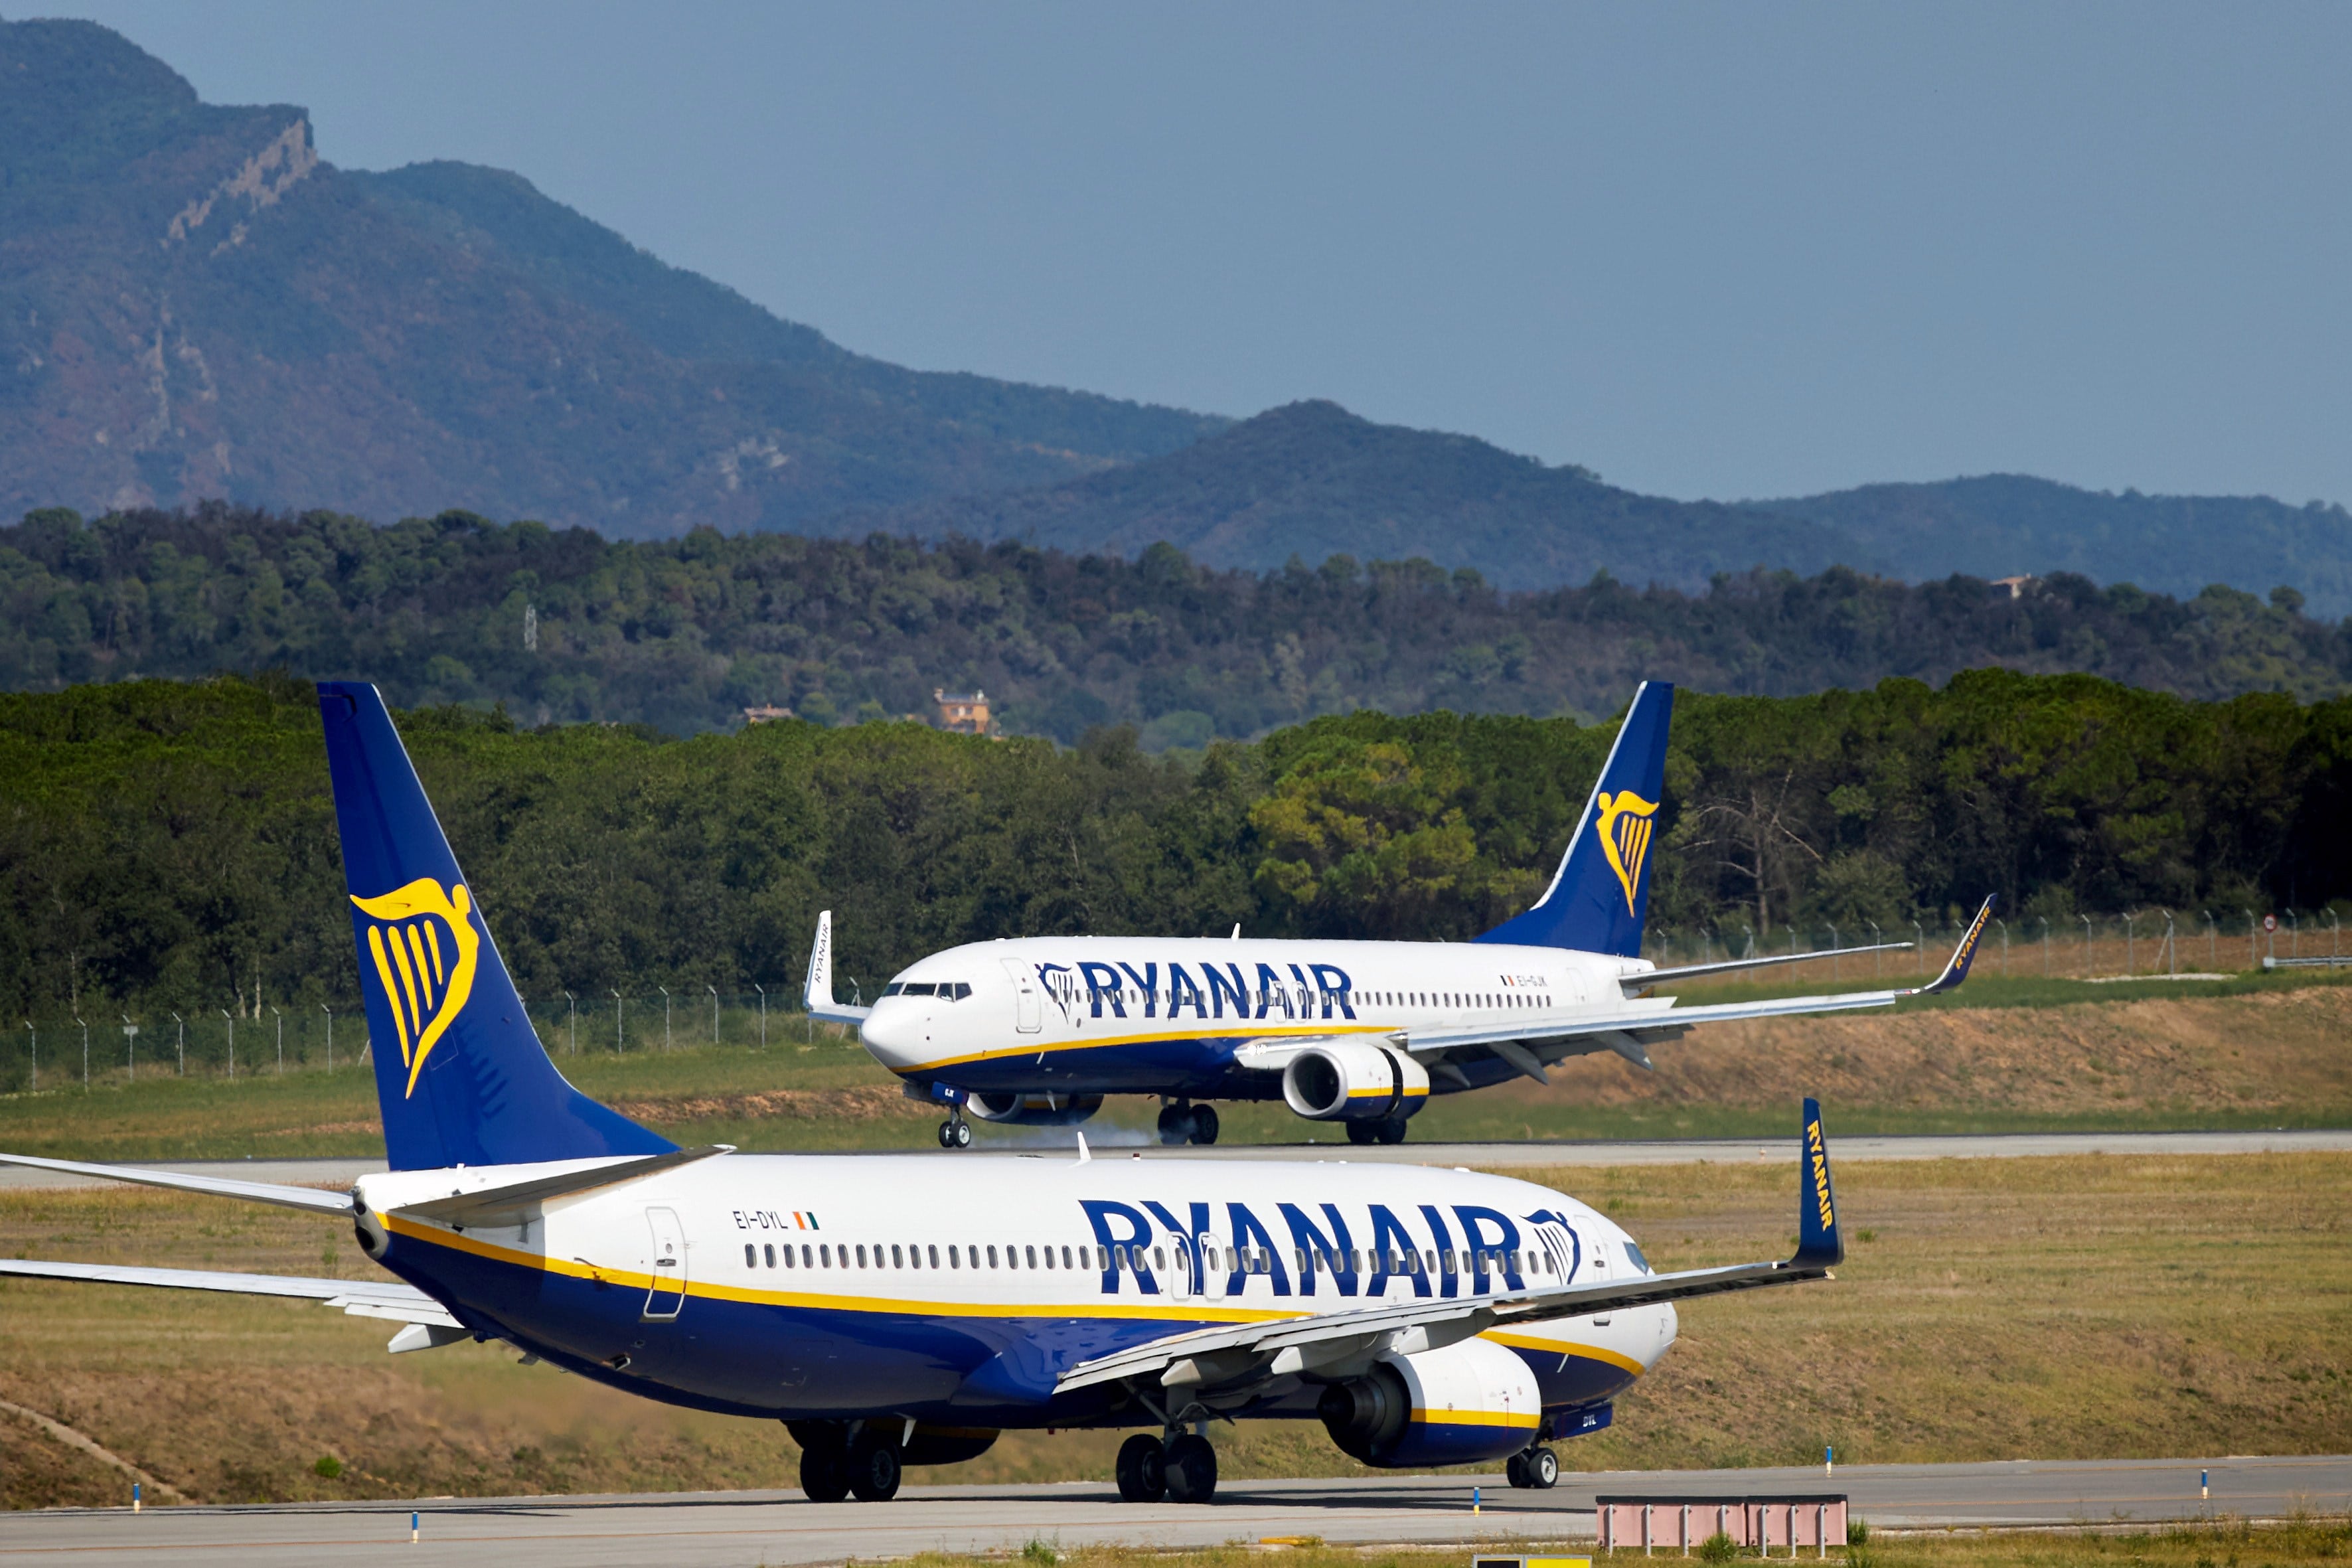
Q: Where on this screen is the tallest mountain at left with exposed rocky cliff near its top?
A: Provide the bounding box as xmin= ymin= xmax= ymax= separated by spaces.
xmin=0 ymin=21 xmax=1223 ymax=536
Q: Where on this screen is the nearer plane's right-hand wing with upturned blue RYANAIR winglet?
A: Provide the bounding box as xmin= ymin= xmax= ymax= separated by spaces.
xmin=1054 ymin=1100 xmax=1846 ymax=1391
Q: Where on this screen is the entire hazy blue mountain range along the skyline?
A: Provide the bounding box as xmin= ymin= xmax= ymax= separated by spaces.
xmin=0 ymin=21 xmax=2352 ymax=616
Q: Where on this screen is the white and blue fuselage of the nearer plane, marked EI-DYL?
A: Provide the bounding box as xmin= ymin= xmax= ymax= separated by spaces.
xmin=358 ymin=1154 xmax=1675 ymax=1429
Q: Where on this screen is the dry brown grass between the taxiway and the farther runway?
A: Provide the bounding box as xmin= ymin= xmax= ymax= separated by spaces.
xmin=0 ymin=1154 xmax=2352 ymax=1507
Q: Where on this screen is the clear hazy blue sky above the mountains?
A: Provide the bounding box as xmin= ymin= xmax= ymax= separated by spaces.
xmin=37 ymin=0 xmax=2352 ymax=501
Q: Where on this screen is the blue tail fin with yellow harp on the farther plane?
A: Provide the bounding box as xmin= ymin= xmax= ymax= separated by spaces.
xmin=1477 ymin=682 xmax=1675 ymax=959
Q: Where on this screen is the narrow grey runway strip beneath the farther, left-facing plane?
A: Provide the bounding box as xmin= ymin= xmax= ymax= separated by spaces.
xmin=0 ymin=1129 xmax=2352 ymax=1187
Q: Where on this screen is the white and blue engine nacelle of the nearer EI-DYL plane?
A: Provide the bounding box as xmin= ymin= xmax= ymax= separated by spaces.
xmin=1315 ymin=1340 xmax=1543 ymax=1469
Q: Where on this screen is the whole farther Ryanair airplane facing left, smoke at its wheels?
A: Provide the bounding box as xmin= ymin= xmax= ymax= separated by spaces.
xmin=805 ymin=682 xmax=1992 ymax=1150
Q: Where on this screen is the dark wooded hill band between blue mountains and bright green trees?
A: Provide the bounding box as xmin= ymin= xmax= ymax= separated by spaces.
xmin=0 ymin=508 xmax=2352 ymax=750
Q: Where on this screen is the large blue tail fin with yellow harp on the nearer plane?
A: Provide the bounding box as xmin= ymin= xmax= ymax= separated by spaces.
xmin=317 ymin=682 xmax=677 ymax=1171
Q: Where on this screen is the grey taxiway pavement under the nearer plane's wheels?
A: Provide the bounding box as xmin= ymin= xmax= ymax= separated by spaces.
xmin=0 ymin=1458 xmax=2352 ymax=1568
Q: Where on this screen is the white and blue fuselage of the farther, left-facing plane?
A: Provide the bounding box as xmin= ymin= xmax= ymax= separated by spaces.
xmin=861 ymin=935 xmax=1668 ymax=1100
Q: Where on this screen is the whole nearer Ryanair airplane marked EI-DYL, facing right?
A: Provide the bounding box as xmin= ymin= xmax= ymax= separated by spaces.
xmin=0 ymin=684 xmax=1844 ymax=1502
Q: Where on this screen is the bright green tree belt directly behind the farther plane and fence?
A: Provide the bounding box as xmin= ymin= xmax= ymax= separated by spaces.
xmin=0 ymin=670 xmax=2352 ymax=1018
